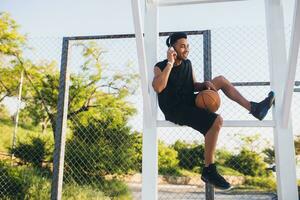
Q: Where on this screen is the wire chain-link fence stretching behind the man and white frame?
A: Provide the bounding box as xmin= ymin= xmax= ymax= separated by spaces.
xmin=0 ymin=27 xmax=300 ymax=199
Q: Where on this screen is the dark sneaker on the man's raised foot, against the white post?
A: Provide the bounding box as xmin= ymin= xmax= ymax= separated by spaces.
xmin=250 ymin=91 xmax=275 ymax=120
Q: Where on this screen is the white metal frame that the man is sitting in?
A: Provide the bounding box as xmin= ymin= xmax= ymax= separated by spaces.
xmin=132 ymin=0 xmax=300 ymax=200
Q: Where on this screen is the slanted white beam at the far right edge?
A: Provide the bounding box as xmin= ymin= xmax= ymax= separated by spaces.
xmin=282 ymin=0 xmax=300 ymax=128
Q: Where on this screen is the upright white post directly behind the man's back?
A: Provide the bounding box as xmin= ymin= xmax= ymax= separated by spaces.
xmin=143 ymin=0 xmax=159 ymax=200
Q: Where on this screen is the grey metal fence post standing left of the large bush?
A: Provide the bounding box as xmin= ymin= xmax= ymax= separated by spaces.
xmin=51 ymin=37 xmax=69 ymax=200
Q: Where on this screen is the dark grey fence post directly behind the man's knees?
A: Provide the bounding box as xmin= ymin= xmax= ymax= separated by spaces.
xmin=203 ymin=30 xmax=215 ymax=200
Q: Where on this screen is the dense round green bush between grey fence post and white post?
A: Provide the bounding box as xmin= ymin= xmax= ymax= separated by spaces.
xmin=65 ymin=116 xmax=137 ymax=183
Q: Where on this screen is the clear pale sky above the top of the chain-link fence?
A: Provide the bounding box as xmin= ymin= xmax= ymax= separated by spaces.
xmin=0 ymin=0 xmax=294 ymax=37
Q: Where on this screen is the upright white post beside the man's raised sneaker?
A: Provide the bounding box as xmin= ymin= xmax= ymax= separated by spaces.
xmin=265 ymin=0 xmax=298 ymax=200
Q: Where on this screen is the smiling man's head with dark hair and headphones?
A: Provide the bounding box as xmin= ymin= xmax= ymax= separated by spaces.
xmin=166 ymin=32 xmax=189 ymax=60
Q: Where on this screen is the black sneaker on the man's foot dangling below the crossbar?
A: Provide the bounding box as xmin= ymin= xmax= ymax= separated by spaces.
xmin=201 ymin=164 xmax=231 ymax=190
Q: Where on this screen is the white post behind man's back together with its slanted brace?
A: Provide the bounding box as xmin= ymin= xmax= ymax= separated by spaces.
xmin=132 ymin=0 xmax=158 ymax=200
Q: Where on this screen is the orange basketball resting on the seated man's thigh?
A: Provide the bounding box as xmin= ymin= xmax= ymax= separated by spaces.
xmin=195 ymin=90 xmax=221 ymax=112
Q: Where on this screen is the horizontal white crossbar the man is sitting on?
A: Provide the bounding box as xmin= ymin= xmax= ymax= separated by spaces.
xmin=157 ymin=120 xmax=275 ymax=127
